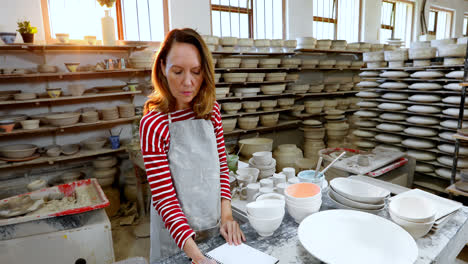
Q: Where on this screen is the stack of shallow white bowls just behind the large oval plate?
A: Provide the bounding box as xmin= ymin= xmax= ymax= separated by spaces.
xmin=328 ymin=178 xmax=390 ymax=213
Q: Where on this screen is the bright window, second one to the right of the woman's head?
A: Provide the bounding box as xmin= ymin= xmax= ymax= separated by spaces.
xmin=312 ymin=0 xmax=361 ymax=42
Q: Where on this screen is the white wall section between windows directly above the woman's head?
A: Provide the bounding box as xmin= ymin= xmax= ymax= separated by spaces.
xmin=168 ymin=0 xmax=211 ymax=35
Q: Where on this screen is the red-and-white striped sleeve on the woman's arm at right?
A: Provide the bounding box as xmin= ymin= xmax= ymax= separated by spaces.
xmin=211 ymin=102 xmax=231 ymax=200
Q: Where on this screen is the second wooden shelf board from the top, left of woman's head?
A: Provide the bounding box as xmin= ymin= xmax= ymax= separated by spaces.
xmin=0 ymin=68 xmax=151 ymax=80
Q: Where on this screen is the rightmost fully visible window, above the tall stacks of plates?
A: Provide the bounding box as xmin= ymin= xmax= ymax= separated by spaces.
xmin=427 ymin=6 xmax=454 ymax=39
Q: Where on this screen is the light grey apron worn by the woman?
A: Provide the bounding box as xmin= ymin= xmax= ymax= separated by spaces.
xmin=150 ymin=114 xmax=221 ymax=263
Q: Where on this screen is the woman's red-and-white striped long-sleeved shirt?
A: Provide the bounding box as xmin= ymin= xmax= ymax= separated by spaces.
xmin=140 ymin=102 xmax=231 ymax=249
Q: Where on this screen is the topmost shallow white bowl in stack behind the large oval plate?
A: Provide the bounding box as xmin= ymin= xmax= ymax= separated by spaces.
xmin=330 ymin=178 xmax=390 ymax=204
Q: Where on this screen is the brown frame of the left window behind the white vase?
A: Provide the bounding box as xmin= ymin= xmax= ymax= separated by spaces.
xmin=41 ymin=0 xmax=169 ymax=44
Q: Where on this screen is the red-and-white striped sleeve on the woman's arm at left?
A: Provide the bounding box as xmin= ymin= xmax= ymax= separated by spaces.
xmin=140 ymin=112 xmax=195 ymax=249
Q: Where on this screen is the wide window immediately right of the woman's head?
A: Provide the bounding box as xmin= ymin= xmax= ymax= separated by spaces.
xmin=211 ymin=0 xmax=284 ymax=39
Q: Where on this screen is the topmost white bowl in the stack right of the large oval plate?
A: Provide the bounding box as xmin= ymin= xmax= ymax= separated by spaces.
xmin=388 ymin=196 xmax=436 ymax=223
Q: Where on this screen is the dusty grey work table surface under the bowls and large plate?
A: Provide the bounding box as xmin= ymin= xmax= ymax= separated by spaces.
xmin=151 ymin=190 xmax=468 ymax=264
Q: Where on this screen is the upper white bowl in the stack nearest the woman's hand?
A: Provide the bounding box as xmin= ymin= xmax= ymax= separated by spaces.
xmin=246 ymin=199 xmax=286 ymax=219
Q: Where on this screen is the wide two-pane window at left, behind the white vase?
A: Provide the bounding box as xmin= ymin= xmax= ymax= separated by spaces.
xmin=41 ymin=0 xmax=167 ymax=42
